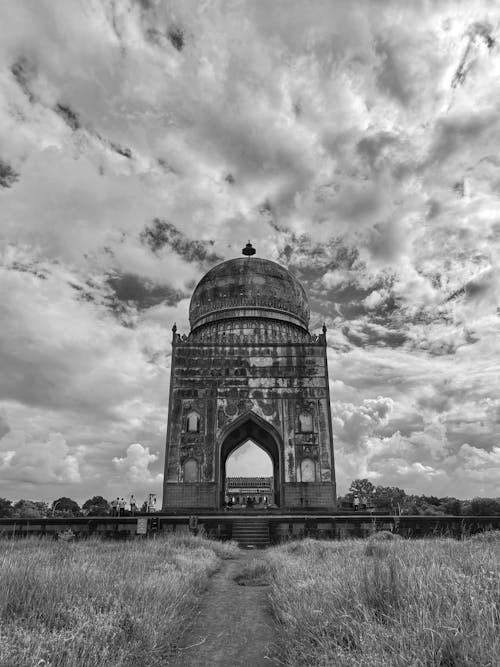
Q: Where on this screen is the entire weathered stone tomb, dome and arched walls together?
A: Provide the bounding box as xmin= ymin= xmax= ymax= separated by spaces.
xmin=163 ymin=250 xmax=336 ymax=510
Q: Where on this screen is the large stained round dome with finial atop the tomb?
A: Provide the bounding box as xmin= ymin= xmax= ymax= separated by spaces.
xmin=189 ymin=253 xmax=309 ymax=331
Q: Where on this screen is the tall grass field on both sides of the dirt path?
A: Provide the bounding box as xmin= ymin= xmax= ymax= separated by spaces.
xmin=0 ymin=536 xmax=500 ymax=667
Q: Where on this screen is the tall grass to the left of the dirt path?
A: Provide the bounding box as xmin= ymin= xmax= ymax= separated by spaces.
xmin=0 ymin=537 xmax=237 ymax=667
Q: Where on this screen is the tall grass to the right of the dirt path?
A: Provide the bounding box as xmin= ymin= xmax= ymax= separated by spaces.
xmin=269 ymin=536 xmax=500 ymax=667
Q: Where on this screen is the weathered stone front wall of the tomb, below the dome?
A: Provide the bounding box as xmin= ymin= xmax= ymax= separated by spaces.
xmin=164 ymin=328 xmax=336 ymax=508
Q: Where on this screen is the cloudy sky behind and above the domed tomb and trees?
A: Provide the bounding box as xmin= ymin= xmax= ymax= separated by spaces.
xmin=0 ymin=0 xmax=500 ymax=502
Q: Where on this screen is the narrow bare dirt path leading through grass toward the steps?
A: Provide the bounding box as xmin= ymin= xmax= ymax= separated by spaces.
xmin=168 ymin=551 xmax=277 ymax=667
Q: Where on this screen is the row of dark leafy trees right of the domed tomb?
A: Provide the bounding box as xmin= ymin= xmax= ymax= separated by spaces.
xmin=339 ymin=479 xmax=500 ymax=516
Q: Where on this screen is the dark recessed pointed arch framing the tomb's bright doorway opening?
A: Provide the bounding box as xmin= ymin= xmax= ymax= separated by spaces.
xmin=218 ymin=412 xmax=283 ymax=507
